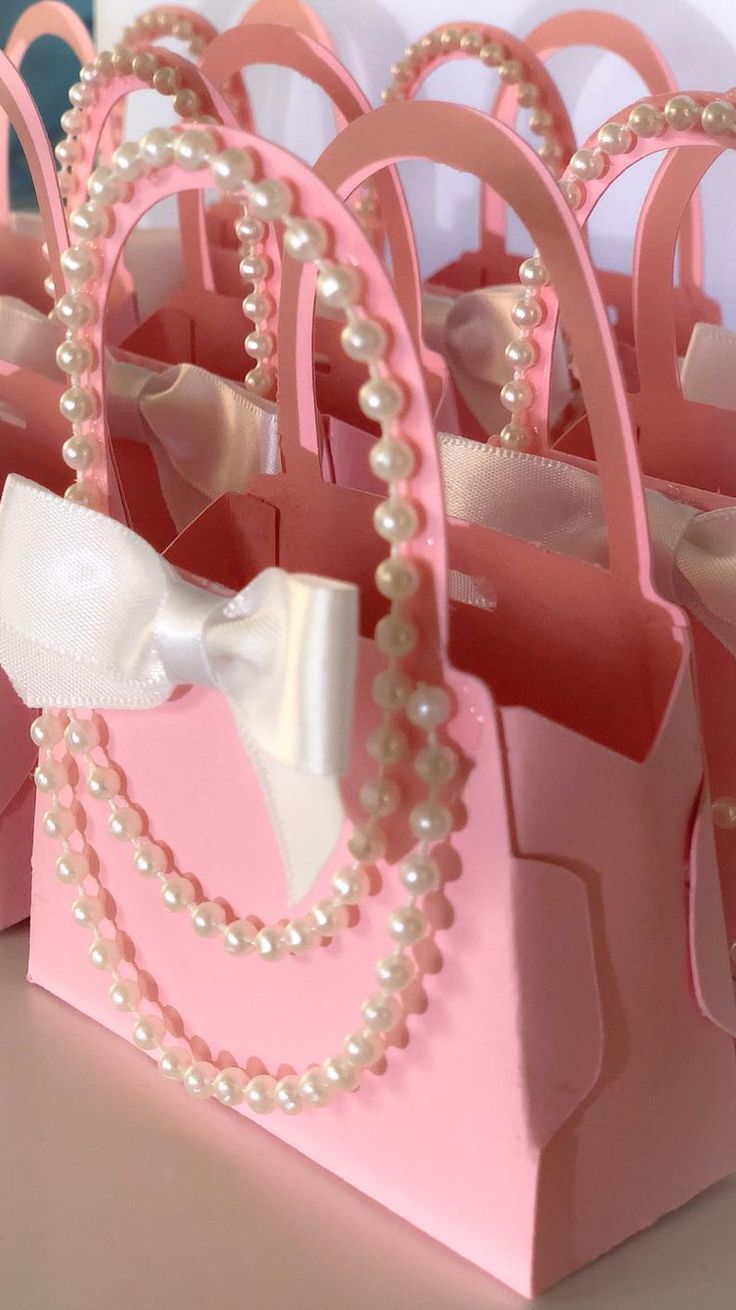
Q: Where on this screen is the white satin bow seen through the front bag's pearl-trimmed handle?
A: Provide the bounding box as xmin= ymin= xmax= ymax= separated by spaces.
xmin=0 ymin=296 xmax=282 ymax=531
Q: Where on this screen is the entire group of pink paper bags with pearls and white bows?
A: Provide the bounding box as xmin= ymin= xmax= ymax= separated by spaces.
xmin=0 ymin=0 xmax=736 ymax=1294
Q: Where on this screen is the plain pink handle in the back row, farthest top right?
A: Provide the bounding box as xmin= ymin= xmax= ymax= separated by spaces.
xmin=483 ymin=9 xmax=703 ymax=288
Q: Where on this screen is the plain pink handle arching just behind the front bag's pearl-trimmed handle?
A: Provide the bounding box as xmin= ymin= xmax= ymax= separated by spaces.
xmin=181 ymin=24 xmax=423 ymax=348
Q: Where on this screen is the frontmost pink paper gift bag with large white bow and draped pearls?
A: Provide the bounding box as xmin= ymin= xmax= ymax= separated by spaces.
xmin=8 ymin=112 xmax=736 ymax=1294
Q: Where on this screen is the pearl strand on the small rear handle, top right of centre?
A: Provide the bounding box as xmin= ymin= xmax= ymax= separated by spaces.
xmin=381 ymin=24 xmax=564 ymax=177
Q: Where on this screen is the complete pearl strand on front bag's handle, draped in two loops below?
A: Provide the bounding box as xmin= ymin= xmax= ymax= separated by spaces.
xmin=31 ymin=128 xmax=457 ymax=1115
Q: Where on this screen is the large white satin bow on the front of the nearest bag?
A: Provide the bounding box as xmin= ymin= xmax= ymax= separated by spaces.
xmin=0 ymin=476 xmax=358 ymax=903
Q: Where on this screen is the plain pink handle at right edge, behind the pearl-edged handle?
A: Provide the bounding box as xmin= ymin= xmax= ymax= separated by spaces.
xmin=634 ymin=145 xmax=723 ymax=394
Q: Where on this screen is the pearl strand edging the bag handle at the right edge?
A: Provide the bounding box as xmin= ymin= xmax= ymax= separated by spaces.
xmin=495 ymin=94 xmax=736 ymax=449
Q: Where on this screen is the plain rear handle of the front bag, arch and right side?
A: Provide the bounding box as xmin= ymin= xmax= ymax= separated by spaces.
xmin=306 ymin=102 xmax=652 ymax=597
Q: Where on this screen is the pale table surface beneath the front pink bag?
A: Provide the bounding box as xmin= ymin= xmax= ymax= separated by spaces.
xmin=0 ymin=927 xmax=736 ymax=1310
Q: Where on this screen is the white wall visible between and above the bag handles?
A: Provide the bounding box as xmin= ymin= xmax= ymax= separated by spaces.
xmin=97 ymin=0 xmax=736 ymax=325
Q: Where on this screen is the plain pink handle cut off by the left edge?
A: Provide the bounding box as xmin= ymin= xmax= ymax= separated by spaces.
xmin=0 ymin=46 xmax=69 ymax=294
